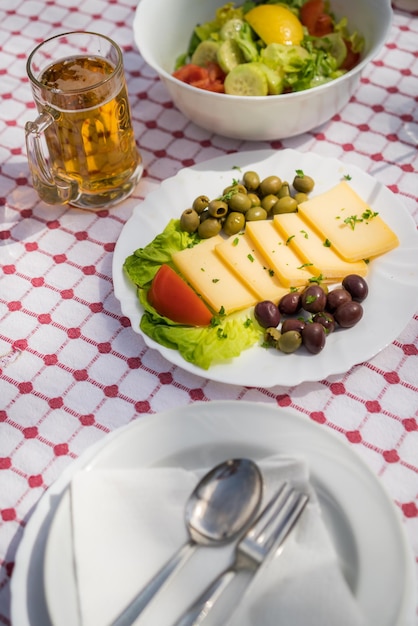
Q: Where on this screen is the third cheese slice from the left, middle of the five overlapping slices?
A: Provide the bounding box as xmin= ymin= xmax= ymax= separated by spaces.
xmin=245 ymin=220 xmax=312 ymax=287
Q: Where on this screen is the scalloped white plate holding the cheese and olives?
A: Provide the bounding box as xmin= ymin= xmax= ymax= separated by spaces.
xmin=113 ymin=150 xmax=418 ymax=387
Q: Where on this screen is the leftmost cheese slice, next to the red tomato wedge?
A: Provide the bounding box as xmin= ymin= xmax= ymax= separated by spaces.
xmin=172 ymin=235 xmax=258 ymax=315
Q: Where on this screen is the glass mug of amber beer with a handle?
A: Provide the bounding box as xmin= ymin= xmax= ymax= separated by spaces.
xmin=25 ymin=32 xmax=143 ymax=210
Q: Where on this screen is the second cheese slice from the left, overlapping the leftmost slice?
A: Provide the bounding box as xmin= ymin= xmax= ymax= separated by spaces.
xmin=216 ymin=233 xmax=289 ymax=302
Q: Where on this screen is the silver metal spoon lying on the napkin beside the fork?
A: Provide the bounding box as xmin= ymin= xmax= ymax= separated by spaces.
xmin=113 ymin=459 xmax=263 ymax=626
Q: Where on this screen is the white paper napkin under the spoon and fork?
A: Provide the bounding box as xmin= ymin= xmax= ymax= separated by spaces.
xmin=71 ymin=456 xmax=365 ymax=626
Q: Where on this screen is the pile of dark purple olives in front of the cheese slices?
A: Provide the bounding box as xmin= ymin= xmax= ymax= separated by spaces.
xmin=254 ymin=274 xmax=368 ymax=354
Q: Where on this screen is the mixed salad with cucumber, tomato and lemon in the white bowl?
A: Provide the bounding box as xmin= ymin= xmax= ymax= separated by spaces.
xmin=173 ymin=0 xmax=364 ymax=96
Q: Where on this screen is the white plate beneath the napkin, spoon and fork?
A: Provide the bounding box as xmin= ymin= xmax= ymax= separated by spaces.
xmin=29 ymin=401 xmax=416 ymax=626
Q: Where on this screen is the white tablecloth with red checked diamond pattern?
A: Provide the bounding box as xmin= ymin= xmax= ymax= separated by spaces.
xmin=0 ymin=0 xmax=418 ymax=626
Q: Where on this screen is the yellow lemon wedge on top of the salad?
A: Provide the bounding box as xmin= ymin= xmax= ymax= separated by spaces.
xmin=245 ymin=4 xmax=303 ymax=46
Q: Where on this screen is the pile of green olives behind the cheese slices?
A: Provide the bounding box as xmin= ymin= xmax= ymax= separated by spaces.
xmin=180 ymin=170 xmax=314 ymax=239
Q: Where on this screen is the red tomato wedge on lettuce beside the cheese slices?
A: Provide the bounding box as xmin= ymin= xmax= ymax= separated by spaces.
xmin=148 ymin=264 xmax=213 ymax=326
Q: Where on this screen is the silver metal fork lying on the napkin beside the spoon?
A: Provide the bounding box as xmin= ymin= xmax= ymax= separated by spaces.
xmin=175 ymin=483 xmax=309 ymax=626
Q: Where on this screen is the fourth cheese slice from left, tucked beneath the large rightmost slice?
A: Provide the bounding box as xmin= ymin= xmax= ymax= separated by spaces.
xmin=273 ymin=213 xmax=368 ymax=282
